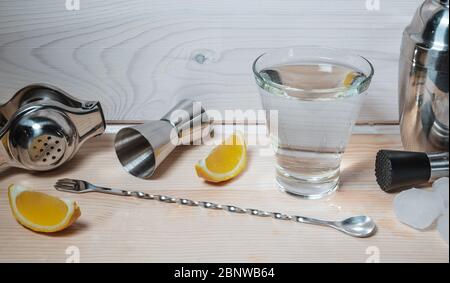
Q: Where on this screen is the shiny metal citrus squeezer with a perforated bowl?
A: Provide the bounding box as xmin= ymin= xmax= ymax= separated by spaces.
xmin=0 ymin=84 xmax=106 ymax=171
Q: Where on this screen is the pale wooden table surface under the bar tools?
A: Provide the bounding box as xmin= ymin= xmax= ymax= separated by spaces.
xmin=0 ymin=126 xmax=449 ymax=263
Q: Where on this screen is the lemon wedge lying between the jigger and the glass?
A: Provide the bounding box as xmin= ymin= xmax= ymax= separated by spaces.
xmin=195 ymin=132 xmax=247 ymax=183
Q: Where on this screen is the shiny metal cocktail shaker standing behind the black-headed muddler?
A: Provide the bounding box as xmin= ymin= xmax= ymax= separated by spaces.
xmin=399 ymin=0 xmax=449 ymax=152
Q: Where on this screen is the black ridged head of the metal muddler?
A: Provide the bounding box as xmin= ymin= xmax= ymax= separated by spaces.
xmin=375 ymin=150 xmax=431 ymax=192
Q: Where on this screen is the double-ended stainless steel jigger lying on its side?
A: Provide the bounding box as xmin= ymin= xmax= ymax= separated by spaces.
xmin=115 ymin=100 xmax=212 ymax=179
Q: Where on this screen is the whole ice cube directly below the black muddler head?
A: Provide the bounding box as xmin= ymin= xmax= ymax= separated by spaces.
xmin=394 ymin=189 xmax=445 ymax=230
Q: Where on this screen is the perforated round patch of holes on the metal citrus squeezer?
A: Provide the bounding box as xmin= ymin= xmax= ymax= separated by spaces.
xmin=29 ymin=135 xmax=66 ymax=165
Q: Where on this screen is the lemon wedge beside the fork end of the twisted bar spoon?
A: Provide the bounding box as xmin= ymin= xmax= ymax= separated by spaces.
xmin=8 ymin=185 xmax=81 ymax=233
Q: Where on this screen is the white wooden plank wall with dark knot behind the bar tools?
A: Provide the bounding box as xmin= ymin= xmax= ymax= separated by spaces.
xmin=0 ymin=0 xmax=421 ymax=122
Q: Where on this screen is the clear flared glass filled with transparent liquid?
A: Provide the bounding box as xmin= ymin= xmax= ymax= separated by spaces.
xmin=253 ymin=47 xmax=374 ymax=199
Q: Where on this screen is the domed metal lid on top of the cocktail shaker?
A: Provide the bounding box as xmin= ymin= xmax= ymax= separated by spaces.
xmin=402 ymin=0 xmax=449 ymax=72
